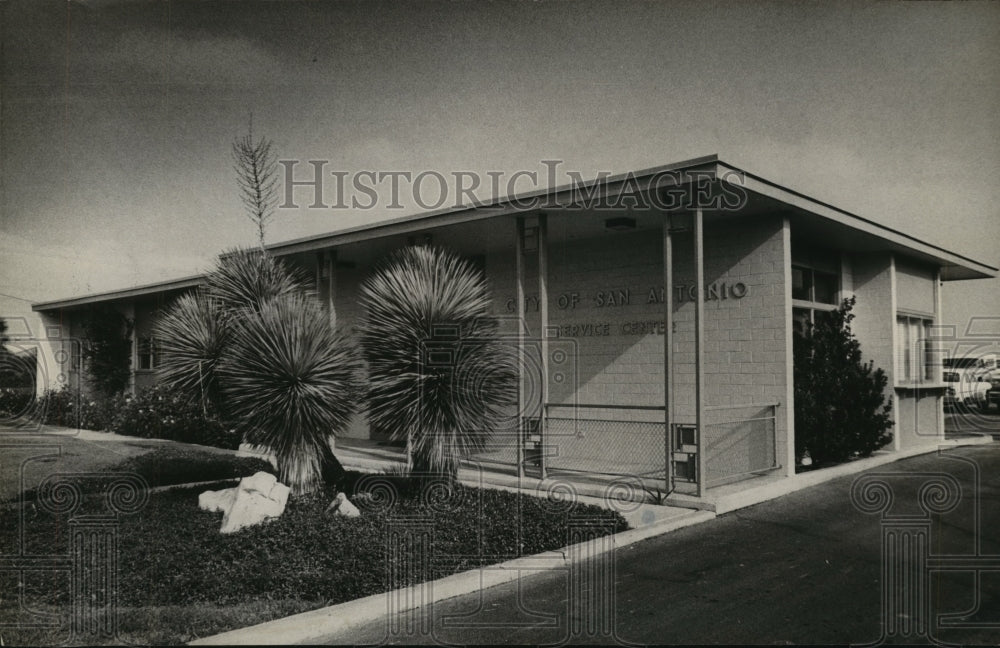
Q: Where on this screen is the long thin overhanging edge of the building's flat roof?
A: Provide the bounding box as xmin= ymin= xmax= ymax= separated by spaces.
xmin=31 ymin=155 xmax=1000 ymax=311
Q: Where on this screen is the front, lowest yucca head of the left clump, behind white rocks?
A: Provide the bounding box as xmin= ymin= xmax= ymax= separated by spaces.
xmin=219 ymin=294 xmax=360 ymax=494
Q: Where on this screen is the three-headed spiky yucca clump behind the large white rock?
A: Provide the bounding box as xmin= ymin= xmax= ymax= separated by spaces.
xmin=155 ymin=250 xmax=359 ymax=494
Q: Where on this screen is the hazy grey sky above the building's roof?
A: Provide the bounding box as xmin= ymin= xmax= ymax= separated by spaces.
xmin=0 ymin=0 xmax=1000 ymax=340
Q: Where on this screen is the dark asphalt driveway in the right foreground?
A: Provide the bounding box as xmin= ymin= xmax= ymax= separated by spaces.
xmin=312 ymin=444 xmax=1000 ymax=645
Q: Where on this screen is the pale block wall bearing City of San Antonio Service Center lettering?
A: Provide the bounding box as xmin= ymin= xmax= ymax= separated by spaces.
xmin=486 ymin=217 xmax=790 ymax=474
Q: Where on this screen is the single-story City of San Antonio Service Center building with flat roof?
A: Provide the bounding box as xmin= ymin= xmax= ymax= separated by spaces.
xmin=27 ymin=156 xmax=997 ymax=496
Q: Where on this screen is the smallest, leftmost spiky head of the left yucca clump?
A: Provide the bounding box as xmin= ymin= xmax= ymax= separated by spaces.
xmin=153 ymin=293 xmax=230 ymax=410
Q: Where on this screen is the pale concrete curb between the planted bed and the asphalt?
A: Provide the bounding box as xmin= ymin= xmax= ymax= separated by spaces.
xmin=189 ymin=511 xmax=716 ymax=646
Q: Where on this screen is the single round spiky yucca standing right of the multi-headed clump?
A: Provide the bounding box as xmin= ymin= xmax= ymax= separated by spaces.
xmin=360 ymin=246 xmax=516 ymax=477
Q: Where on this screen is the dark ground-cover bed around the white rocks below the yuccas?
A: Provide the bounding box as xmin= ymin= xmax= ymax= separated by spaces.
xmin=0 ymin=473 xmax=627 ymax=645
